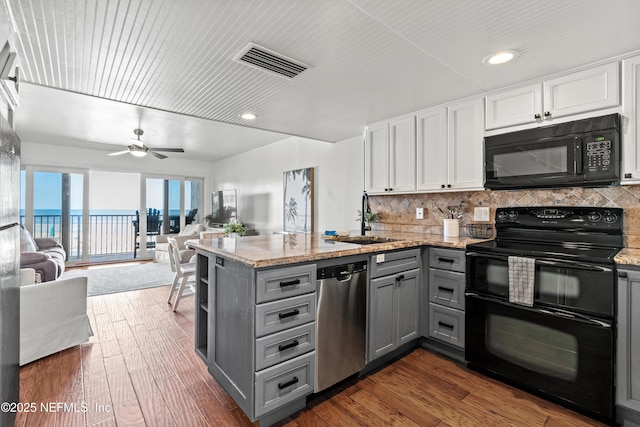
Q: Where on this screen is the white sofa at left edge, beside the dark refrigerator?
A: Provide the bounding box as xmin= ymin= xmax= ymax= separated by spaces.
xmin=20 ymin=268 xmax=93 ymax=366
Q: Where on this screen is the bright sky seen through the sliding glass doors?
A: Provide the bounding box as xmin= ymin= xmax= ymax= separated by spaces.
xmin=20 ymin=171 xmax=191 ymax=213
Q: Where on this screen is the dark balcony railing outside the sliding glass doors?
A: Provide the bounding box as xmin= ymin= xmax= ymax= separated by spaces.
xmin=20 ymin=215 xmax=154 ymax=261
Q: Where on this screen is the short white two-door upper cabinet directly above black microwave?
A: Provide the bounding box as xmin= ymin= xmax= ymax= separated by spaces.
xmin=486 ymin=62 xmax=620 ymax=130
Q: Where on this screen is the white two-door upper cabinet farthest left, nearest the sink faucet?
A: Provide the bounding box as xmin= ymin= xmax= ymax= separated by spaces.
xmin=365 ymin=115 xmax=416 ymax=194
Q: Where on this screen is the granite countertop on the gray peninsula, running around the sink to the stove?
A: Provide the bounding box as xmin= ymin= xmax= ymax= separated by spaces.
xmin=188 ymin=232 xmax=482 ymax=268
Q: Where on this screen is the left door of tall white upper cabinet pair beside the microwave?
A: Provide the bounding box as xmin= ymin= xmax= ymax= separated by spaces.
xmin=416 ymin=108 xmax=448 ymax=191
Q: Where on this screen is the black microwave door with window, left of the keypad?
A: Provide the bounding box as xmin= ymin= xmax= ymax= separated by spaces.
xmin=485 ymin=136 xmax=584 ymax=189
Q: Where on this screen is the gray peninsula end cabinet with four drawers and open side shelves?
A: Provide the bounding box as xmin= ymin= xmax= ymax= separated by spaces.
xmin=196 ymin=252 xmax=316 ymax=424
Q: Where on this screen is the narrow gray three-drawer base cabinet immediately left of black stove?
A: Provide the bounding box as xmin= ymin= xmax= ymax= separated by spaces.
xmin=428 ymin=248 xmax=465 ymax=349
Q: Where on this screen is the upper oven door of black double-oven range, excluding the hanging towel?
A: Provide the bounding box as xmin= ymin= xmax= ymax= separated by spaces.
xmin=466 ymin=251 xmax=615 ymax=318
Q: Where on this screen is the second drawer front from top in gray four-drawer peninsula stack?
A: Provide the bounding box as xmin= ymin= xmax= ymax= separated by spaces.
xmin=256 ymin=292 xmax=316 ymax=337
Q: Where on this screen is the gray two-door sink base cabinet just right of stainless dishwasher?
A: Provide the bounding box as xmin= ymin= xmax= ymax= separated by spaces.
xmin=367 ymin=249 xmax=420 ymax=362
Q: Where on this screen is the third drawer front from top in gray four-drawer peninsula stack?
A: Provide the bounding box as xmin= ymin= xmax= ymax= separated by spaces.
xmin=256 ymin=322 xmax=316 ymax=371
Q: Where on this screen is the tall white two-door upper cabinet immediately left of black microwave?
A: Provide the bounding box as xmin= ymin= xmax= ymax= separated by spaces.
xmin=416 ymin=99 xmax=484 ymax=191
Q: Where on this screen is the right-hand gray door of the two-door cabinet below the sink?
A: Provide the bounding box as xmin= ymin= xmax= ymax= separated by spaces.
xmin=396 ymin=269 xmax=420 ymax=346
